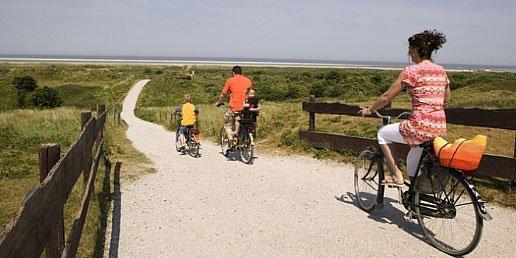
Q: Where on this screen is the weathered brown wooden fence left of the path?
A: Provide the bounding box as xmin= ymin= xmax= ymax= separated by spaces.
xmin=0 ymin=105 xmax=107 ymax=257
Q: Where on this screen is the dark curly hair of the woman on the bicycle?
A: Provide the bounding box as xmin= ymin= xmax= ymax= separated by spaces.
xmin=408 ymin=30 xmax=446 ymax=59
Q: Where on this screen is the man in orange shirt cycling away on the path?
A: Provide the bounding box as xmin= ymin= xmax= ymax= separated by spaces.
xmin=215 ymin=65 xmax=253 ymax=142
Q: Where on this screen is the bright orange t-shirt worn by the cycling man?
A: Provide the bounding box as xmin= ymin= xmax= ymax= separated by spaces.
xmin=222 ymin=74 xmax=253 ymax=112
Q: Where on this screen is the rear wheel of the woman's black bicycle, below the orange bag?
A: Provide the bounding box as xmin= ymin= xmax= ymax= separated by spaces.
xmin=414 ymin=165 xmax=483 ymax=256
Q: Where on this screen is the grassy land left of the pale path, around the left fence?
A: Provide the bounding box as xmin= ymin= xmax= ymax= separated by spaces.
xmin=0 ymin=64 xmax=152 ymax=257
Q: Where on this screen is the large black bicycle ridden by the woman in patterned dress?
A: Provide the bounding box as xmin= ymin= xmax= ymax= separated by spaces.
xmin=354 ymin=112 xmax=492 ymax=256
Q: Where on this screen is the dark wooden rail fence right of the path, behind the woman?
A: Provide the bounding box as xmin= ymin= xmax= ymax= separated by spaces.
xmin=299 ymin=96 xmax=516 ymax=182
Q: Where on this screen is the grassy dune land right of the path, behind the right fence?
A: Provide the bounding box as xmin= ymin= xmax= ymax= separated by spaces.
xmin=136 ymin=67 xmax=516 ymax=207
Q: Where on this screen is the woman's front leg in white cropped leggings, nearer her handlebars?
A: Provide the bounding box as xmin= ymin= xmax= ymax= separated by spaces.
xmin=377 ymin=123 xmax=406 ymax=182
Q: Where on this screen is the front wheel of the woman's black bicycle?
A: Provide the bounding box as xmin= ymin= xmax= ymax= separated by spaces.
xmin=354 ymin=149 xmax=385 ymax=212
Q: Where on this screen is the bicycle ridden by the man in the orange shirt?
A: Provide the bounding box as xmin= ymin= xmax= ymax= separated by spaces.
xmin=220 ymin=114 xmax=256 ymax=164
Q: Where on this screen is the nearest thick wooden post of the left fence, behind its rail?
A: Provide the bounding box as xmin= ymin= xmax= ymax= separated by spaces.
xmin=39 ymin=144 xmax=64 ymax=258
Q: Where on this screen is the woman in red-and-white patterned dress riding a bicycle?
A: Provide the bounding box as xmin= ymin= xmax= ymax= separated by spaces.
xmin=359 ymin=30 xmax=451 ymax=185
